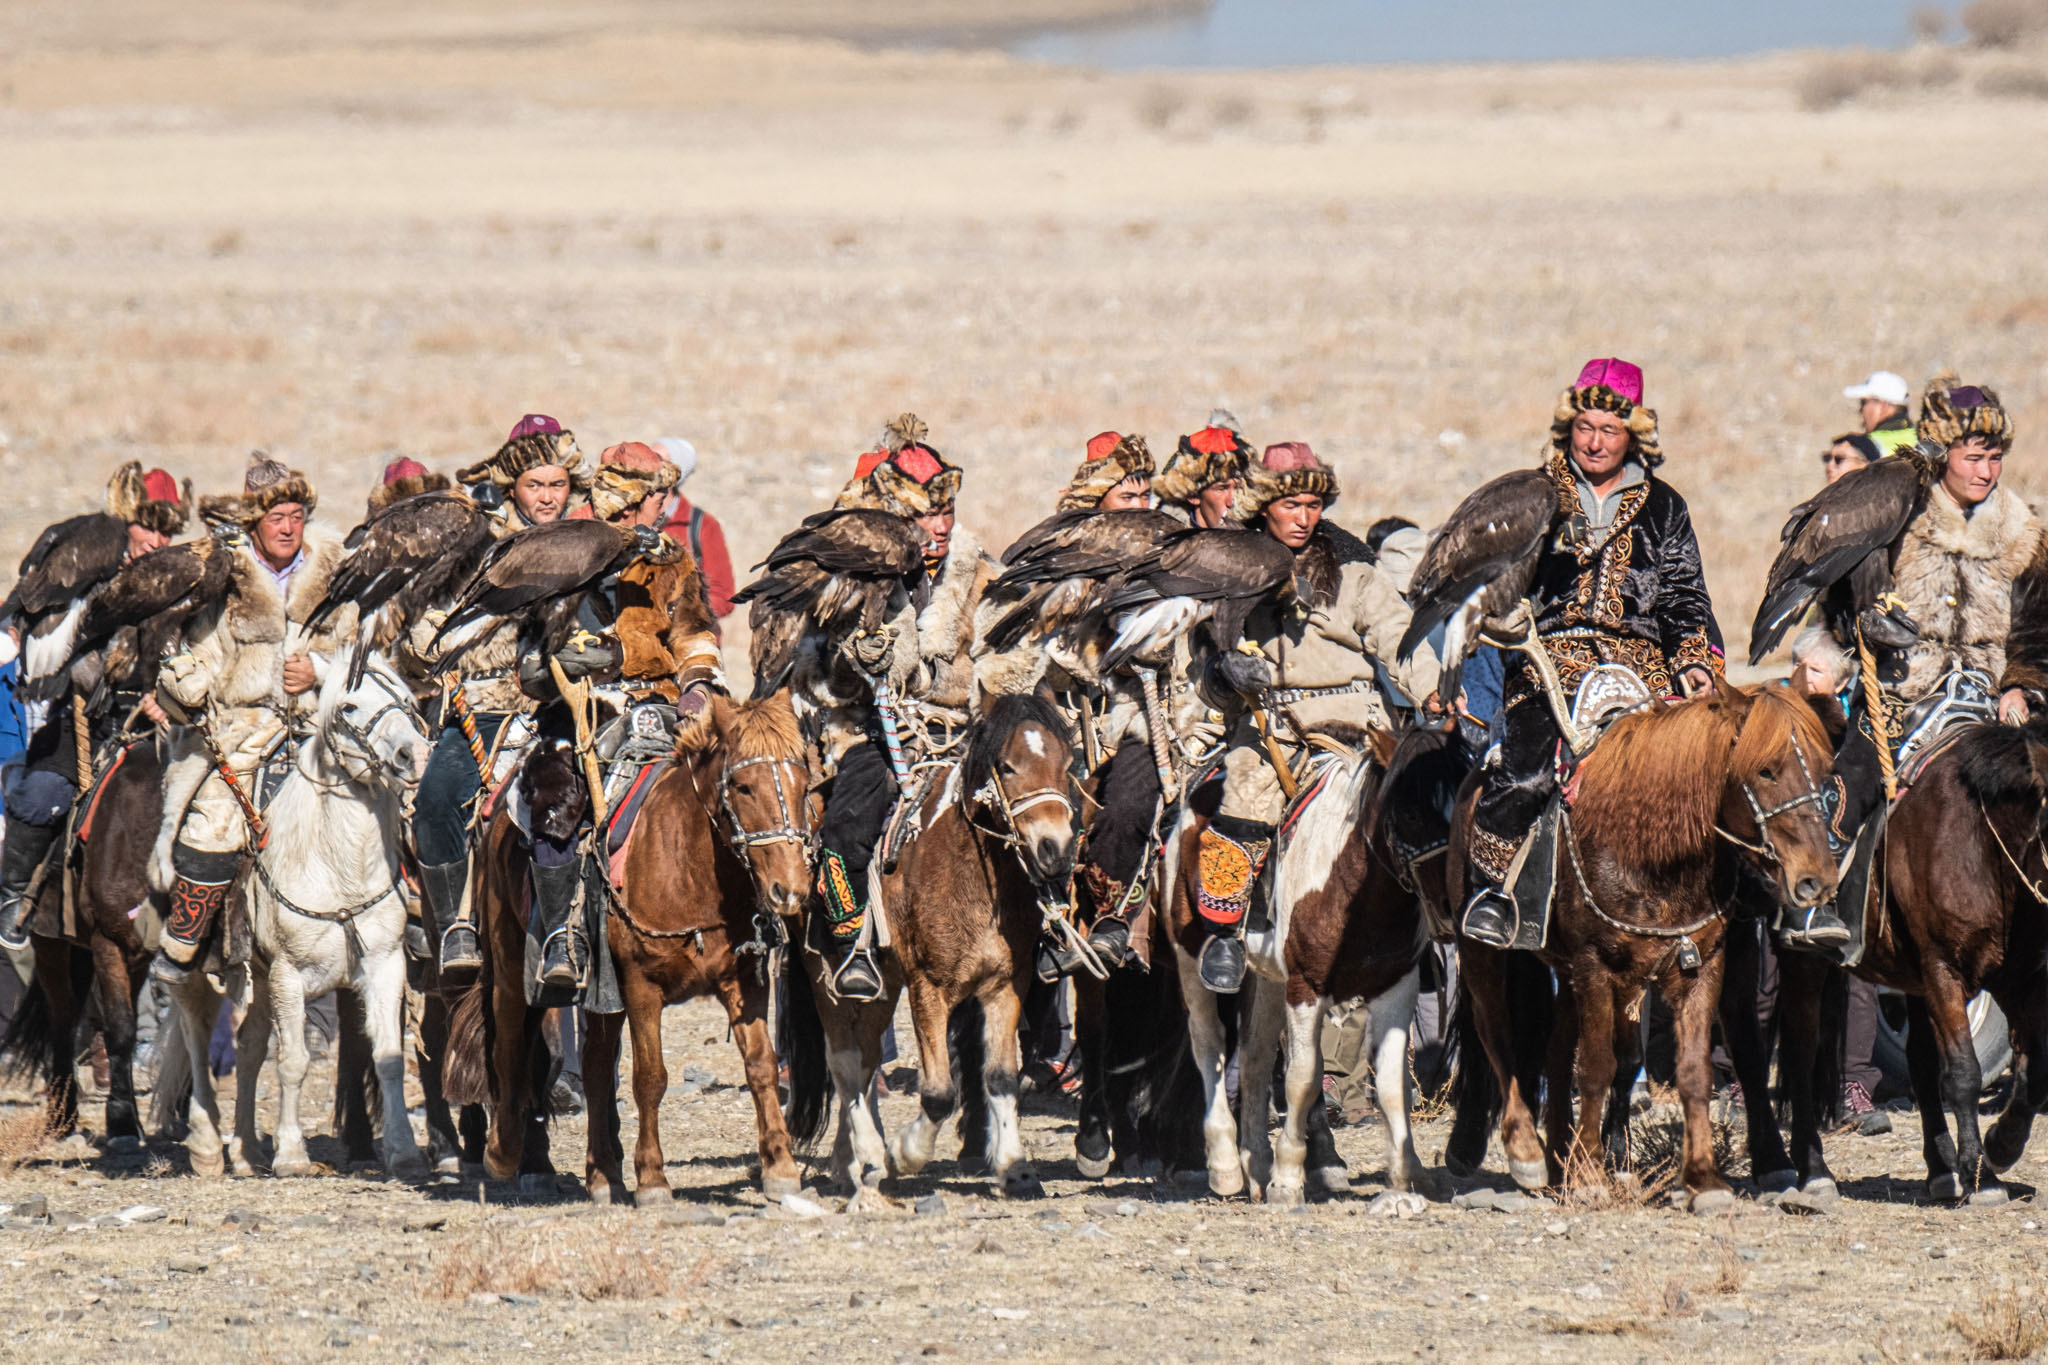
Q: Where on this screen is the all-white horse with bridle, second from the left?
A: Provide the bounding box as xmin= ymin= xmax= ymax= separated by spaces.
xmin=174 ymin=653 xmax=430 ymax=1179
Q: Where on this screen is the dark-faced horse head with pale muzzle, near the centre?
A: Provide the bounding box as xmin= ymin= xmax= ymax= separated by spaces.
xmin=961 ymin=696 xmax=1077 ymax=888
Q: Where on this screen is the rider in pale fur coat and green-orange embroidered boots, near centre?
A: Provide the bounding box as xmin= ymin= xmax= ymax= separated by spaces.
xmin=799 ymin=413 xmax=993 ymax=1001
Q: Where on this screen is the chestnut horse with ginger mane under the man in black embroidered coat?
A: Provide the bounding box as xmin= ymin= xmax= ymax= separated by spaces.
xmin=1448 ymin=686 xmax=1835 ymax=1207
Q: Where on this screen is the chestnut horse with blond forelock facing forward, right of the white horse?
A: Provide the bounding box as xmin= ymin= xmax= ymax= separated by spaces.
xmin=584 ymin=692 xmax=817 ymax=1205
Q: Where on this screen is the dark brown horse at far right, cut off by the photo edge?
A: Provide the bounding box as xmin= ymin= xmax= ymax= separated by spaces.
xmin=1777 ymin=724 xmax=2048 ymax=1203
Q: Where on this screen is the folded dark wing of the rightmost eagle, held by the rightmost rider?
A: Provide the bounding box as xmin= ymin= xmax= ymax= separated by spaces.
xmin=1749 ymin=454 xmax=1929 ymax=663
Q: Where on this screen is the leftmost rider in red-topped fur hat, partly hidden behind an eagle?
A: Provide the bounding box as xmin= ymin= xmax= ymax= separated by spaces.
xmin=0 ymin=460 xmax=193 ymax=950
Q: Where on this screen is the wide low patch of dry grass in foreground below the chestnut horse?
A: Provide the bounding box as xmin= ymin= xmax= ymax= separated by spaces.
xmin=428 ymin=1220 xmax=711 ymax=1300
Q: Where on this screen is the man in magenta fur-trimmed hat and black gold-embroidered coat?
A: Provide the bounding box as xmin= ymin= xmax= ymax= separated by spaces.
xmin=1462 ymin=358 xmax=1722 ymax=948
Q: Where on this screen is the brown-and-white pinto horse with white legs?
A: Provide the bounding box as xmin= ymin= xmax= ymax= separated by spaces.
xmin=1161 ymin=757 xmax=1436 ymax=1207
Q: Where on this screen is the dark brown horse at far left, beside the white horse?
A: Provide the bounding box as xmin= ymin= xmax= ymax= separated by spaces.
xmin=0 ymin=739 xmax=164 ymax=1144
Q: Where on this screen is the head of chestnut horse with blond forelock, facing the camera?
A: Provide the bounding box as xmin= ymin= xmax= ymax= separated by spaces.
xmin=684 ymin=688 xmax=819 ymax=921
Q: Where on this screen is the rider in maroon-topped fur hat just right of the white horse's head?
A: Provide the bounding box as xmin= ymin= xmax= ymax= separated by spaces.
xmin=412 ymin=413 xmax=590 ymax=986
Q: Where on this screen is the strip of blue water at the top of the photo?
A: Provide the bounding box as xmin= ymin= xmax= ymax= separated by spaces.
xmin=1010 ymin=0 xmax=1913 ymax=70
